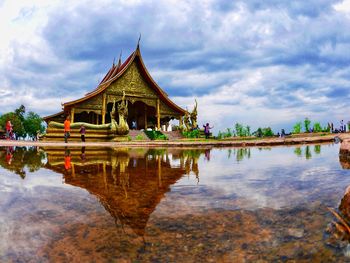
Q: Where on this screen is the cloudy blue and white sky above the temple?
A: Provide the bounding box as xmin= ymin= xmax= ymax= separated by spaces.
xmin=0 ymin=0 xmax=350 ymax=132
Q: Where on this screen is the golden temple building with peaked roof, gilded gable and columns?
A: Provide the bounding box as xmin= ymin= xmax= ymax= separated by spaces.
xmin=44 ymin=45 xmax=186 ymax=133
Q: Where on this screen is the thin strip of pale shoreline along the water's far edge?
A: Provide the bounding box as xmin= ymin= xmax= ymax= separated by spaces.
xmin=0 ymin=133 xmax=344 ymax=148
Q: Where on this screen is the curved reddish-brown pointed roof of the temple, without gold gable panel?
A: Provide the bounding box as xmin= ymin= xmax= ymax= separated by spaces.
xmin=63 ymin=45 xmax=186 ymax=114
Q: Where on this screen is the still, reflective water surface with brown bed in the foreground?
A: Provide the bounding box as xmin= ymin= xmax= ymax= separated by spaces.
xmin=0 ymin=144 xmax=350 ymax=262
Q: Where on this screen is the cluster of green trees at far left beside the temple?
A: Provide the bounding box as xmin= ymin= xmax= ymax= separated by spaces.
xmin=0 ymin=105 xmax=45 ymax=139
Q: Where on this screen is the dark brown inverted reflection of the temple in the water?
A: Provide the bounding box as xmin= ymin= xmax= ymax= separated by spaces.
xmin=45 ymin=147 xmax=210 ymax=236
